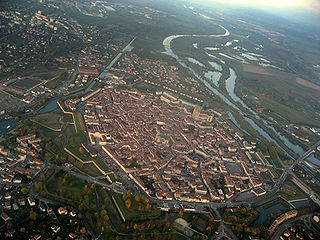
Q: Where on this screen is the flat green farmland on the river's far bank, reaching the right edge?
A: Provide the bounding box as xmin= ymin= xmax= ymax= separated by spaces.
xmin=236 ymin=66 xmax=320 ymax=126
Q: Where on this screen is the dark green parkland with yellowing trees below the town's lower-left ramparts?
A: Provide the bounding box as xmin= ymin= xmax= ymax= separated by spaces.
xmin=35 ymin=169 xmax=192 ymax=239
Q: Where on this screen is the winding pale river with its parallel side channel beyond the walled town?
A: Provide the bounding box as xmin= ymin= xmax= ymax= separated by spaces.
xmin=163 ymin=25 xmax=319 ymax=164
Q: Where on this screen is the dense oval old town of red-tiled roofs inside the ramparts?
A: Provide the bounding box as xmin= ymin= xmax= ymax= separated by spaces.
xmin=83 ymin=87 xmax=268 ymax=203
